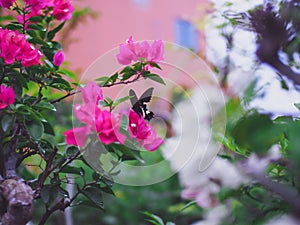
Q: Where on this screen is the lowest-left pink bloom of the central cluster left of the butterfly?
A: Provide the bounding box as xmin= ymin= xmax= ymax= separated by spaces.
xmin=64 ymin=126 xmax=90 ymax=147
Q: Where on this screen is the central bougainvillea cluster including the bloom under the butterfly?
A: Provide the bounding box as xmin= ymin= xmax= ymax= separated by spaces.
xmin=64 ymin=82 xmax=163 ymax=151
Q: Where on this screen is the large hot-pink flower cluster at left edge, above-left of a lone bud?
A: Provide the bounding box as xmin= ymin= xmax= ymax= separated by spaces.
xmin=0 ymin=28 xmax=42 ymax=66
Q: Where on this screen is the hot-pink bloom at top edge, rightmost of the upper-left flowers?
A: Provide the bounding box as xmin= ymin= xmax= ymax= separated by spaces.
xmin=53 ymin=0 xmax=74 ymax=20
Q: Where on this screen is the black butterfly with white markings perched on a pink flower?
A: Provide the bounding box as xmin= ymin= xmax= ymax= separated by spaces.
xmin=129 ymin=88 xmax=154 ymax=121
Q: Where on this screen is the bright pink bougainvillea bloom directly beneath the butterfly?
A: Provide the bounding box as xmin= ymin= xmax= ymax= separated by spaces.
xmin=128 ymin=110 xmax=164 ymax=151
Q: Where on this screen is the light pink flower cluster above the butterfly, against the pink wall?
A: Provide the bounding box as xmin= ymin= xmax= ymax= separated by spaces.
xmin=117 ymin=36 xmax=164 ymax=65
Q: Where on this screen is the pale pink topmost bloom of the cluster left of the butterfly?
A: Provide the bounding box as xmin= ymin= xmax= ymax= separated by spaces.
xmin=80 ymin=82 xmax=103 ymax=105
